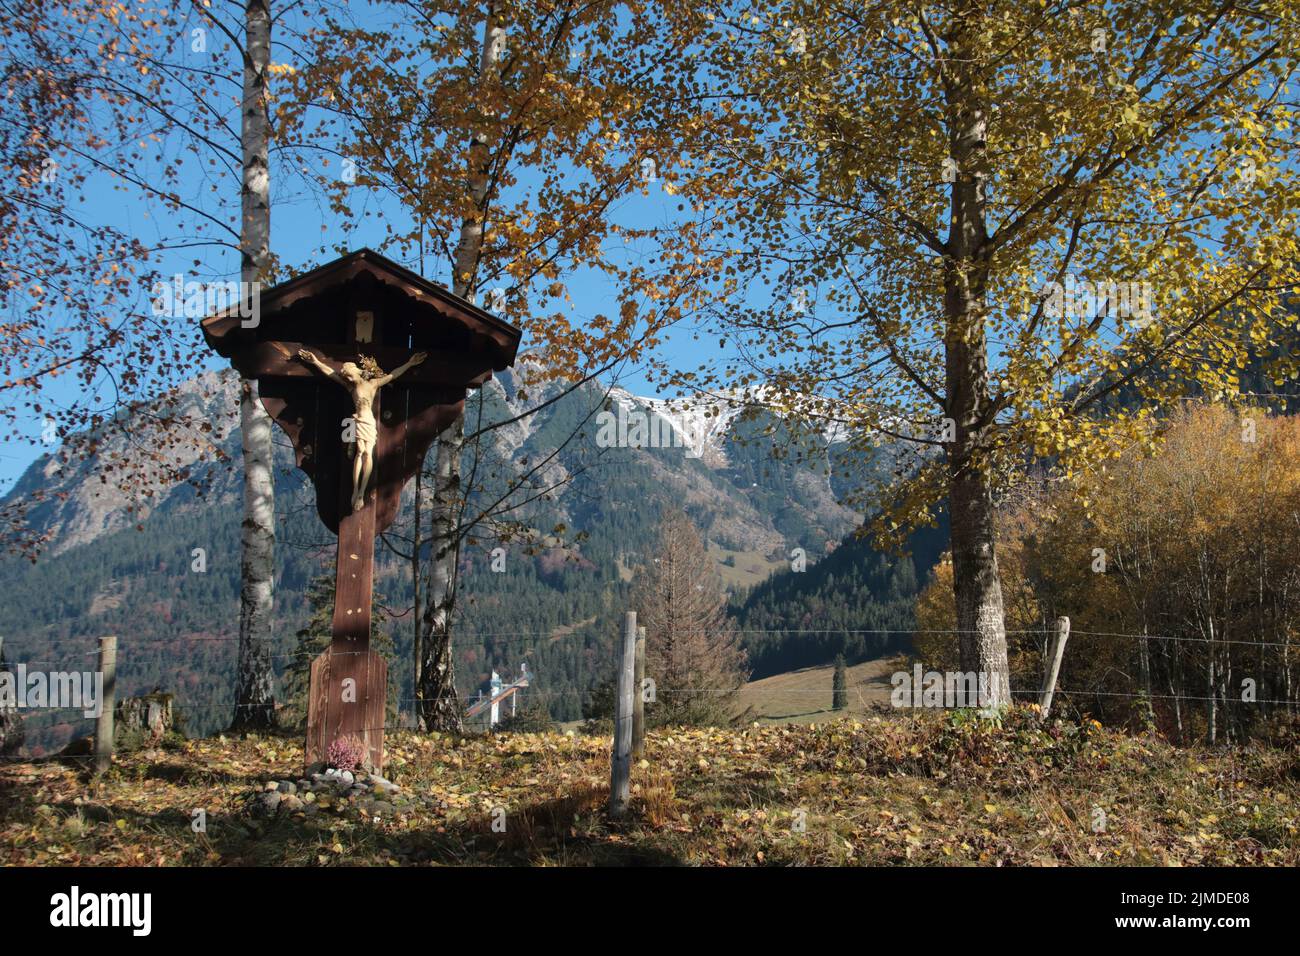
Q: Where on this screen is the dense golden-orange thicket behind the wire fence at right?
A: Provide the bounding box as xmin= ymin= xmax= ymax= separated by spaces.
xmin=917 ymin=405 xmax=1300 ymax=739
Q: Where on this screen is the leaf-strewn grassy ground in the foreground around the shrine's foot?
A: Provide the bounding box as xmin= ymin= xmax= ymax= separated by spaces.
xmin=0 ymin=709 xmax=1300 ymax=865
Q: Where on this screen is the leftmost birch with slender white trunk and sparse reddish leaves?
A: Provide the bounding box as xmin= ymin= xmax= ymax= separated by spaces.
xmin=0 ymin=0 xmax=327 ymax=726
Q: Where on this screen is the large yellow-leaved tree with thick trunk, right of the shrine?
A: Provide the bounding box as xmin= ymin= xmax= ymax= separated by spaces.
xmin=666 ymin=0 xmax=1300 ymax=704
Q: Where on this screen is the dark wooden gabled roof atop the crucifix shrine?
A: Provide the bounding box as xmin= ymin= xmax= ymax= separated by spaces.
xmin=202 ymin=248 xmax=523 ymax=372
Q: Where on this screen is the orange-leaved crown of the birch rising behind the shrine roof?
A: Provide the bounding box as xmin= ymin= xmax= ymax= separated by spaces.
xmin=280 ymin=0 xmax=716 ymax=378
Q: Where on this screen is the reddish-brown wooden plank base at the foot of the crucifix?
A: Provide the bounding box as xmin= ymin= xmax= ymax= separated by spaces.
xmin=307 ymin=641 xmax=389 ymax=773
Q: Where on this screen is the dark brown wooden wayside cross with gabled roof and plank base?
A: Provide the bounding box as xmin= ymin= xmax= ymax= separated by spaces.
xmin=203 ymin=248 xmax=520 ymax=769
